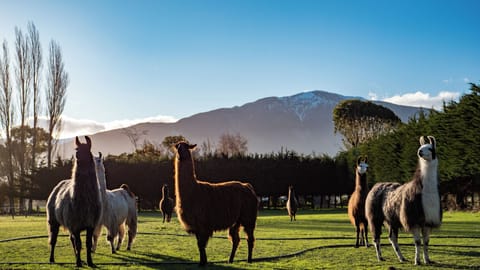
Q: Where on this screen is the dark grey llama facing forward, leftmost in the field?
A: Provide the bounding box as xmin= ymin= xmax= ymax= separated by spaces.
xmin=47 ymin=136 xmax=102 ymax=267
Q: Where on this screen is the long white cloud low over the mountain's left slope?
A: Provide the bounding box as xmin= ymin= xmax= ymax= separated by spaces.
xmin=29 ymin=115 xmax=177 ymax=139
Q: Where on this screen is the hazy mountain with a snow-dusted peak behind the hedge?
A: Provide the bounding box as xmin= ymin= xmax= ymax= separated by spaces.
xmin=60 ymin=91 xmax=428 ymax=157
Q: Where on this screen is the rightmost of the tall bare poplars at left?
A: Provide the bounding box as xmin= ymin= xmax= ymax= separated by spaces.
xmin=46 ymin=40 xmax=69 ymax=168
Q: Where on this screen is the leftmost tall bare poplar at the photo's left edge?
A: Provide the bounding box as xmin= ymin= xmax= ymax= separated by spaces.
xmin=0 ymin=40 xmax=15 ymax=217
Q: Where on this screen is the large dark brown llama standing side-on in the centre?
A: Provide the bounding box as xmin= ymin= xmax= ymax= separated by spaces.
xmin=174 ymin=142 xmax=258 ymax=266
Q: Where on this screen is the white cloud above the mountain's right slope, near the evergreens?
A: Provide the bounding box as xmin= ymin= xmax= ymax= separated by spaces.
xmin=380 ymin=91 xmax=460 ymax=109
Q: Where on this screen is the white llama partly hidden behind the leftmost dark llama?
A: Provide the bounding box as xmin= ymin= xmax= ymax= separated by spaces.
xmin=93 ymin=153 xmax=137 ymax=254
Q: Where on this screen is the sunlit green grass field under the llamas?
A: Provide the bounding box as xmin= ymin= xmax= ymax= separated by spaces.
xmin=0 ymin=209 xmax=480 ymax=269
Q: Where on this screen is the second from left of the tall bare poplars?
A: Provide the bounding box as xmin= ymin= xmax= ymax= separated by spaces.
xmin=15 ymin=27 xmax=32 ymax=211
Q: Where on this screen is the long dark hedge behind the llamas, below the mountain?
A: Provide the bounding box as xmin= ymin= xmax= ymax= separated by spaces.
xmin=29 ymin=151 xmax=353 ymax=209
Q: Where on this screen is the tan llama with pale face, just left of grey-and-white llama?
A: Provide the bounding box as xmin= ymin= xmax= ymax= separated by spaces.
xmin=348 ymin=157 xmax=369 ymax=248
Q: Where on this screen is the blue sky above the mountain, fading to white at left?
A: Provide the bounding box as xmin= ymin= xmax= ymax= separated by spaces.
xmin=0 ymin=0 xmax=480 ymax=137
